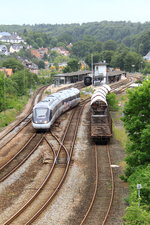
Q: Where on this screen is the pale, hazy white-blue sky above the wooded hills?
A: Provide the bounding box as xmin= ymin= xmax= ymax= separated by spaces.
xmin=0 ymin=0 xmax=150 ymax=25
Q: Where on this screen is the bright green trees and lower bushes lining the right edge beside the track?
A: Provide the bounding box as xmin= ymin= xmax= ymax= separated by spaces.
xmin=123 ymin=80 xmax=150 ymax=225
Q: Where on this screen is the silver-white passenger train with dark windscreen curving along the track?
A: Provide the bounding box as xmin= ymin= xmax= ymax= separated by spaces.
xmin=32 ymin=88 xmax=80 ymax=129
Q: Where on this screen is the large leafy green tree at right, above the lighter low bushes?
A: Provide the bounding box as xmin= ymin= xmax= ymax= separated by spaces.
xmin=123 ymin=80 xmax=150 ymax=171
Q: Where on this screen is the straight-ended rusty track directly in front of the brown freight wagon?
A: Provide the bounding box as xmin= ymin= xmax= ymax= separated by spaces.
xmin=80 ymin=145 xmax=115 ymax=225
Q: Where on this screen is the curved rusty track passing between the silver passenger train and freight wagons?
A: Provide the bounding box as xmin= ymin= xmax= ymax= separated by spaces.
xmin=3 ymin=97 xmax=86 ymax=224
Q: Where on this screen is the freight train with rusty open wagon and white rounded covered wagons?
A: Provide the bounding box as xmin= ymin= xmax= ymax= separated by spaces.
xmin=91 ymin=84 xmax=112 ymax=144
